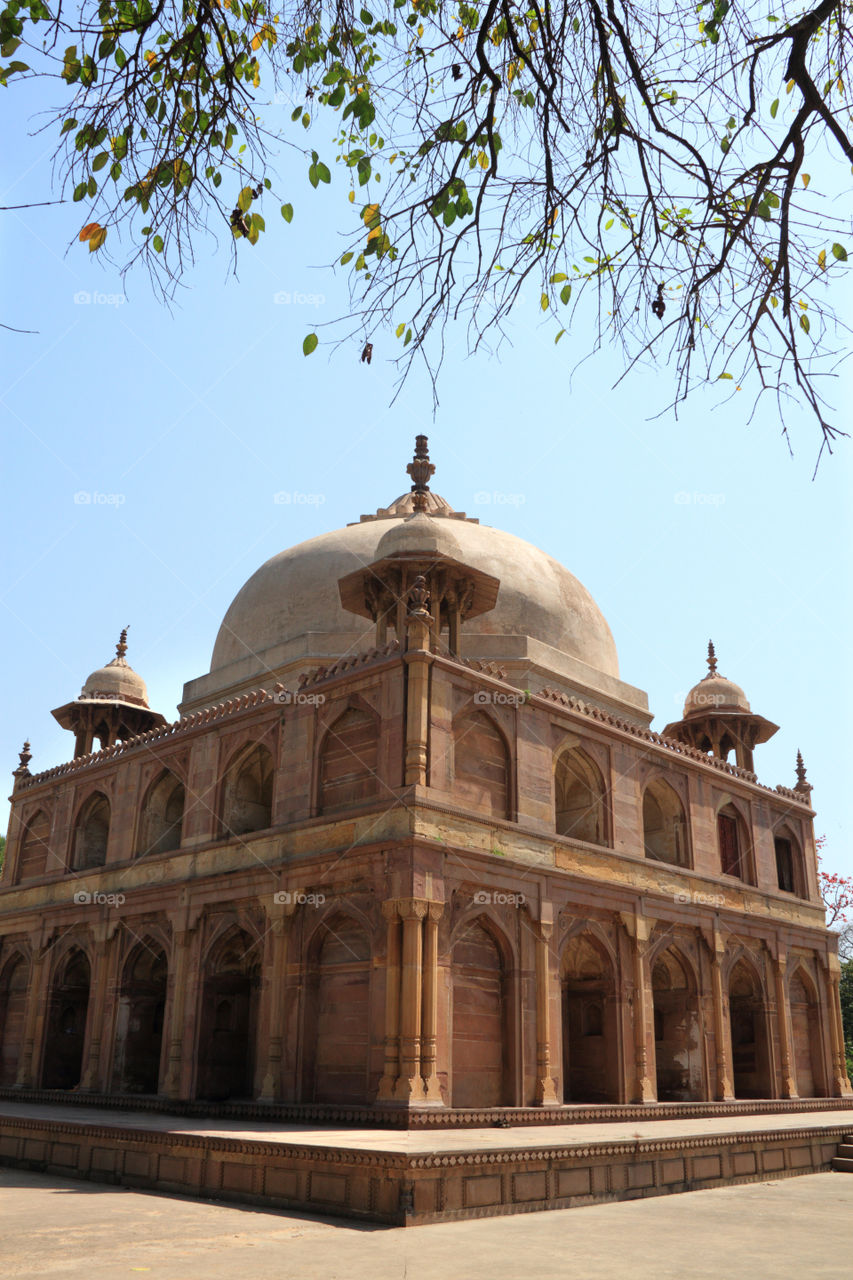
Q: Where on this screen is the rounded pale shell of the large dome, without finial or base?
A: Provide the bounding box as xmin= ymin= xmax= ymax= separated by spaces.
xmin=210 ymin=508 xmax=619 ymax=678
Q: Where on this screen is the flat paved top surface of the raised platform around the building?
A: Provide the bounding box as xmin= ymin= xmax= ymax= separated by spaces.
xmin=0 ymin=1100 xmax=853 ymax=1157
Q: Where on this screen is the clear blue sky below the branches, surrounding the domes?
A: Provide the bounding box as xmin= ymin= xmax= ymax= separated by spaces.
xmin=0 ymin=80 xmax=853 ymax=874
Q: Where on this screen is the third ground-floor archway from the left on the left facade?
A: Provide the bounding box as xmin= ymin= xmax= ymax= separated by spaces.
xmin=113 ymin=941 xmax=168 ymax=1093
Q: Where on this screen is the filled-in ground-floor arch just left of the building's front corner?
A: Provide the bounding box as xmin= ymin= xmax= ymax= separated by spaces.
xmin=304 ymin=915 xmax=373 ymax=1103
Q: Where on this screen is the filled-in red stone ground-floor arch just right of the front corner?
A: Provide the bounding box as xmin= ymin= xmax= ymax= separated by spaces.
xmin=451 ymin=920 xmax=514 ymax=1107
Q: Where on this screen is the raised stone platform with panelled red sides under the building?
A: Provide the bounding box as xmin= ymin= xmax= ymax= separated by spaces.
xmin=0 ymin=1100 xmax=853 ymax=1226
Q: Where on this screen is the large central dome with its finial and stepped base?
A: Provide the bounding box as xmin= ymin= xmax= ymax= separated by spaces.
xmin=181 ymin=436 xmax=648 ymax=722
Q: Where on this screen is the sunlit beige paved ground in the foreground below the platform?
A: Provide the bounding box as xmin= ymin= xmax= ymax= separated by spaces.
xmin=0 ymin=1169 xmax=853 ymax=1280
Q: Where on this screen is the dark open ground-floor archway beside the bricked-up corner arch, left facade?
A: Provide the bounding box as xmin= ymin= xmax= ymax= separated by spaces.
xmin=196 ymin=928 xmax=260 ymax=1102
